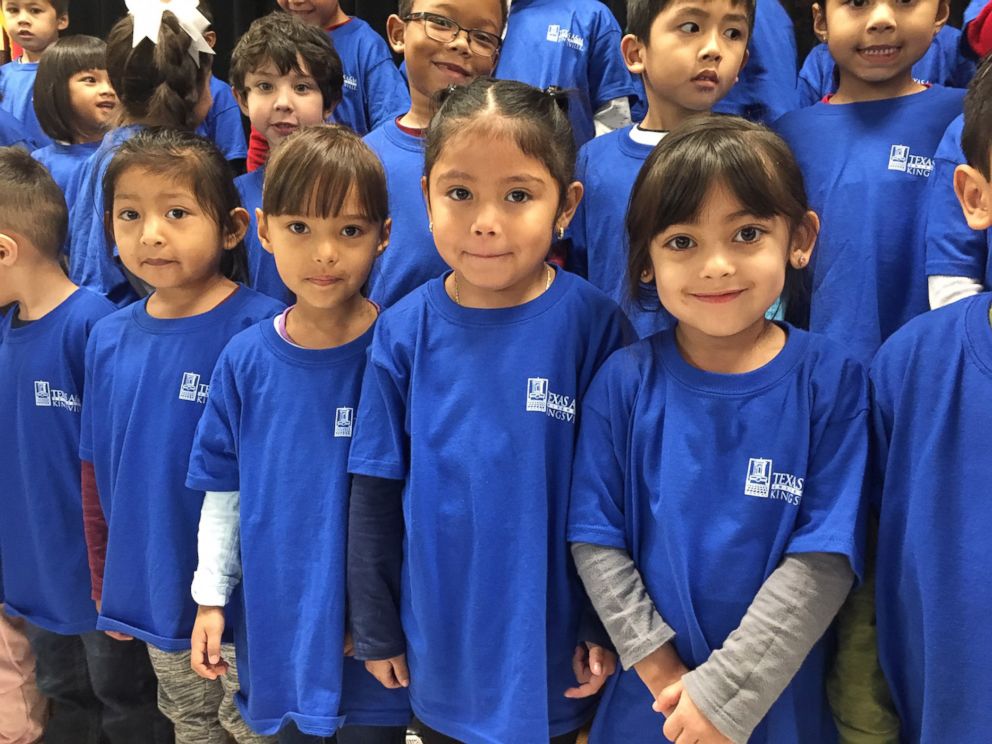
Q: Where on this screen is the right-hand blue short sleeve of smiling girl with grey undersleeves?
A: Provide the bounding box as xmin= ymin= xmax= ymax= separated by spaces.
xmin=786 ymin=361 xmax=868 ymax=580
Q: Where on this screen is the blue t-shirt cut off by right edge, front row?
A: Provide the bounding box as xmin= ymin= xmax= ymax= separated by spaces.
xmin=871 ymin=294 xmax=992 ymax=744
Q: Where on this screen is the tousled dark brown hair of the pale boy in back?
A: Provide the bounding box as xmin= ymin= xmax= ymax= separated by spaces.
xmin=231 ymin=11 xmax=344 ymax=111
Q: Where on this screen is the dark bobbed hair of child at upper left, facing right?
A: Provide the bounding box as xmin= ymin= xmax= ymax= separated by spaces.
xmin=34 ymin=35 xmax=107 ymax=143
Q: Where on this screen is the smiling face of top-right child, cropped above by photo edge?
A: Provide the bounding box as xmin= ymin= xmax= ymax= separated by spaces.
xmin=813 ymin=0 xmax=948 ymax=101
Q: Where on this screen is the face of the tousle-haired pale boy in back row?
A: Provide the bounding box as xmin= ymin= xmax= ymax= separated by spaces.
xmin=235 ymin=57 xmax=331 ymax=147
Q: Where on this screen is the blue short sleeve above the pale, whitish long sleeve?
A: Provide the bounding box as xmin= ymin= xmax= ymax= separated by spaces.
xmin=186 ymin=351 xmax=241 ymax=491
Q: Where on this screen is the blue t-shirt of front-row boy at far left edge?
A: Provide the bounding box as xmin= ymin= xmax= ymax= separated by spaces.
xmin=0 ymin=289 xmax=114 ymax=635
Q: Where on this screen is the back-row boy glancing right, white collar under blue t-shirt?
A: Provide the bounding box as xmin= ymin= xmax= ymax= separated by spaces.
xmin=566 ymin=0 xmax=754 ymax=337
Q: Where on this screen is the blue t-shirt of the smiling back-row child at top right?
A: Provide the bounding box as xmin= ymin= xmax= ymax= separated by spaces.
xmin=775 ymin=85 xmax=964 ymax=364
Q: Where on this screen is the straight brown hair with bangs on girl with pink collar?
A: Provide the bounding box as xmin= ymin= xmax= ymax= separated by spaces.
xmin=262 ymin=125 xmax=389 ymax=225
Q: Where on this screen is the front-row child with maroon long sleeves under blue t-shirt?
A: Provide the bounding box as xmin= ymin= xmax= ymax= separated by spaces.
xmin=79 ymin=129 xmax=281 ymax=744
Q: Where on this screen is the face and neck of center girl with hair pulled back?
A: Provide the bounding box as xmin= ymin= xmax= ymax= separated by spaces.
xmin=423 ymin=125 xmax=582 ymax=307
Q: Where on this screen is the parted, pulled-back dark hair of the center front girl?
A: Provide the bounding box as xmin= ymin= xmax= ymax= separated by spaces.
xmin=424 ymin=78 xmax=575 ymax=208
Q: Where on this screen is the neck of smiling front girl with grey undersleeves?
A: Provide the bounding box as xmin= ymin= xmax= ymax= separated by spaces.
xmin=675 ymin=317 xmax=785 ymax=375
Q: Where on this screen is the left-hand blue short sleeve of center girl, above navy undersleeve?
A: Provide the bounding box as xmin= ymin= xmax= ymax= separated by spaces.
xmin=348 ymin=328 xmax=410 ymax=480
